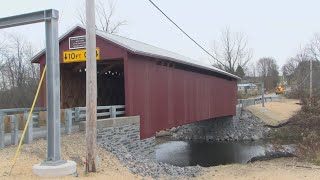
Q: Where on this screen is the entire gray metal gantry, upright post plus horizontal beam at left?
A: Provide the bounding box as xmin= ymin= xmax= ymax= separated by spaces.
xmin=0 ymin=9 xmax=61 ymax=165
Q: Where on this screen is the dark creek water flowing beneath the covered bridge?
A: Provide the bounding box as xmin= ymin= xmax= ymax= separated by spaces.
xmin=156 ymin=138 xmax=266 ymax=167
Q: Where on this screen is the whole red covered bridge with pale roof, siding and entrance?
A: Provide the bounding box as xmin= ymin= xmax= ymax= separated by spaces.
xmin=32 ymin=25 xmax=238 ymax=139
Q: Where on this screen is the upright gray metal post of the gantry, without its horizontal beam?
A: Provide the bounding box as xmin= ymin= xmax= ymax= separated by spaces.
xmin=45 ymin=11 xmax=61 ymax=162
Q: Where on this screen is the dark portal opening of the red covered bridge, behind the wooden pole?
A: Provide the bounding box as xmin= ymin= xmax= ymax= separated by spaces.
xmin=60 ymin=60 xmax=125 ymax=109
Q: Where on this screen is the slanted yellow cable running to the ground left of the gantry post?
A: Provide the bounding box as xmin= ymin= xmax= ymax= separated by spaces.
xmin=9 ymin=65 xmax=47 ymax=175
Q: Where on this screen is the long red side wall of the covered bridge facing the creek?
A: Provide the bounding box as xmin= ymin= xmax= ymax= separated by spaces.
xmin=125 ymin=54 xmax=237 ymax=138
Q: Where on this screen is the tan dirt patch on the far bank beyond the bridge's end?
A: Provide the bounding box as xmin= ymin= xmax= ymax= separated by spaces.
xmin=246 ymin=99 xmax=301 ymax=126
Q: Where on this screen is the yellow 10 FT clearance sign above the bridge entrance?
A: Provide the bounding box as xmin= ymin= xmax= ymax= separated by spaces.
xmin=63 ymin=48 xmax=100 ymax=63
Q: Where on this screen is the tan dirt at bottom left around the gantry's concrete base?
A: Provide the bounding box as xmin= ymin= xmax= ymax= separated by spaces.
xmin=0 ymin=133 xmax=143 ymax=179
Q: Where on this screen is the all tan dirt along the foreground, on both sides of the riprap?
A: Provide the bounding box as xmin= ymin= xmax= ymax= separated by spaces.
xmin=0 ymin=127 xmax=320 ymax=180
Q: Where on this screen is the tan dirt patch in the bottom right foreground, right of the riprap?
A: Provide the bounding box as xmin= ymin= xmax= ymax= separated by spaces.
xmin=196 ymin=158 xmax=320 ymax=180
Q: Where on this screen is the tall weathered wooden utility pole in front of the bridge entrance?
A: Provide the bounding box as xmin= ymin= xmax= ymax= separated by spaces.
xmin=86 ymin=0 xmax=97 ymax=172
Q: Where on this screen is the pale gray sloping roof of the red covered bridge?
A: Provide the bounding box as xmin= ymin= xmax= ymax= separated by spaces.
xmin=31 ymin=25 xmax=240 ymax=79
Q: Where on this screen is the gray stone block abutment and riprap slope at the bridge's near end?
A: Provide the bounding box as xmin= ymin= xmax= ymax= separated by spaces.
xmin=92 ymin=116 xmax=202 ymax=179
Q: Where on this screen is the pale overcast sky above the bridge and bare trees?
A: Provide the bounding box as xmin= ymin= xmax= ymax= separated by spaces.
xmin=0 ymin=0 xmax=320 ymax=66
